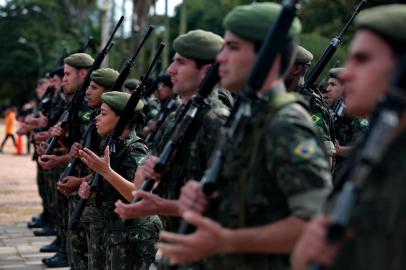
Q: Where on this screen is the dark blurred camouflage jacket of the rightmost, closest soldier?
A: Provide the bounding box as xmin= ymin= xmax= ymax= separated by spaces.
xmin=331 ymin=130 xmax=406 ymax=270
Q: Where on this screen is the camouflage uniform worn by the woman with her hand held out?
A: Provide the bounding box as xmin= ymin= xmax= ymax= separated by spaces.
xmin=94 ymin=132 xmax=162 ymax=270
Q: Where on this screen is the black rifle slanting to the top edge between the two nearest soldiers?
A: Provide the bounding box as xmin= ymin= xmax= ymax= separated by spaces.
xmin=304 ymin=0 xmax=367 ymax=89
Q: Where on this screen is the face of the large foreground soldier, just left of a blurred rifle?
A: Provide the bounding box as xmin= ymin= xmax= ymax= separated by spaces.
xmin=217 ymin=31 xmax=255 ymax=92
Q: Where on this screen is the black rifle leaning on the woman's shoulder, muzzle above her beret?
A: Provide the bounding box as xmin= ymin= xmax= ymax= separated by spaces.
xmin=68 ymin=43 xmax=165 ymax=229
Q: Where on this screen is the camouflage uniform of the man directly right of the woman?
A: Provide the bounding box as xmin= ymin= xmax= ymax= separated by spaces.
xmin=152 ymin=89 xmax=229 ymax=231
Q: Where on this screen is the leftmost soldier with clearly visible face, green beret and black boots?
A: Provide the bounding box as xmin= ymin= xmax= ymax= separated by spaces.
xmin=38 ymin=53 xmax=94 ymax=267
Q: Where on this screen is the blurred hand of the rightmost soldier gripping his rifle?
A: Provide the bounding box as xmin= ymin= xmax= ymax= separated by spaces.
xmin=292 ymin=217 xmax=340 ymax=270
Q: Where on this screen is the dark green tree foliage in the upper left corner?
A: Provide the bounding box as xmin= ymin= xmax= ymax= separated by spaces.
xmin=0 ymin=0 xmax=99 ymax=105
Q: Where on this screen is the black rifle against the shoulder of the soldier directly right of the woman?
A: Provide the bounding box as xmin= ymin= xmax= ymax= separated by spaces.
xmin=131 ymin=63 xmax=220 ymax=209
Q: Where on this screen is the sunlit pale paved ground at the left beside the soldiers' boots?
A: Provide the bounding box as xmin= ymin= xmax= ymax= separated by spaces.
xmin=0 ymin=123 xmax=68 ymax=270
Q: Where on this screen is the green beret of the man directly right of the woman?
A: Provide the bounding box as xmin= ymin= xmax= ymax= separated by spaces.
xmin=173 ymin=30 xmax=224 ymax=60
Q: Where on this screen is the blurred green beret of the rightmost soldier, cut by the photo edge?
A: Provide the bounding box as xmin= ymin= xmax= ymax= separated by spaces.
xmin=355 ymin=4 xmax=406 ymax=48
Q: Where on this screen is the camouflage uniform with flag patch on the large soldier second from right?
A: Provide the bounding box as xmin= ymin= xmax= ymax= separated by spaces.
xmin=207 ymin=85 xmax=331 ymax=270
